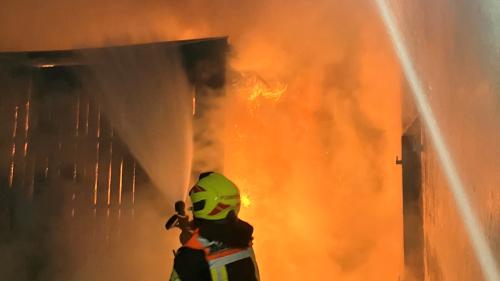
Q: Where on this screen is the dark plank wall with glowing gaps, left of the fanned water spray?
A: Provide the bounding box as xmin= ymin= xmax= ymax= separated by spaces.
xmin=0 ymin=67 xmax=148 ymax=245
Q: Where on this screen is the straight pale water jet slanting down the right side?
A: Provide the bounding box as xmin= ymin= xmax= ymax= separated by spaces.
xmin=375 ymin=0 xmax=500 ymax=281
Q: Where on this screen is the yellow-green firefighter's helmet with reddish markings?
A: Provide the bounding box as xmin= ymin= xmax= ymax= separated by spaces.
xmin=189 ymin=172 xmax=240 ymax=220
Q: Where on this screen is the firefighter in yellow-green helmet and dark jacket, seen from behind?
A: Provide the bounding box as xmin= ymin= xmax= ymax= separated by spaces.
xmin=170 ymin=172 xmax=259 ymax=281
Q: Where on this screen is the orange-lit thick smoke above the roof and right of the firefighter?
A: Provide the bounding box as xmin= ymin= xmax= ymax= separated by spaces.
xmin=0 ymin=0 xmax=402 ymax=280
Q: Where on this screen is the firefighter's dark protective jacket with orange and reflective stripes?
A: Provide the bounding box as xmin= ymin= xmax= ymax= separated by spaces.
xmin=170 ymin=219 xmax=259 ymax=281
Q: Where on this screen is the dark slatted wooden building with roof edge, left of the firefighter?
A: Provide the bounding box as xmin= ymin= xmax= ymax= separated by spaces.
xmin=0 ymin=38 xmax=228 ymax=280
